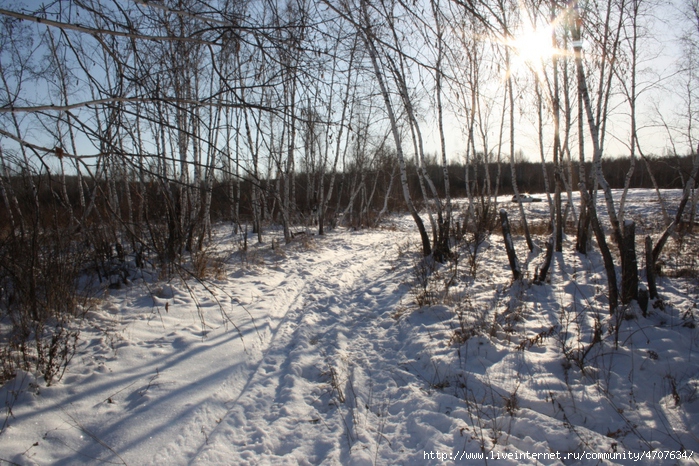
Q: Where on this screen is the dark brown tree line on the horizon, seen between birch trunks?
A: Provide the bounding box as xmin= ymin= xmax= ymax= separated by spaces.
xmin=0 ymin=154 xmax=692 ymax=231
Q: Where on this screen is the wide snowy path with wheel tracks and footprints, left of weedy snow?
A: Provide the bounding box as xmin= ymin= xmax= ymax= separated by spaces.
xmin=0 ymin=225 xmax=404 ymax=464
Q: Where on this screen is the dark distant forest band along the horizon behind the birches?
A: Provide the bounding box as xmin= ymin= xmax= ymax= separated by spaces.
xmin=0 ymin=156 xmax=692 ymax=232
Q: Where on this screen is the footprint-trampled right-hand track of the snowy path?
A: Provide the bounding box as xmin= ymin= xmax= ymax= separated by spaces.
xmin=194 ymin=232 xmax=405 ymax=464
